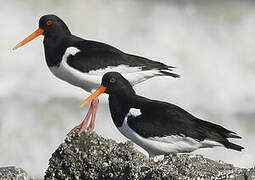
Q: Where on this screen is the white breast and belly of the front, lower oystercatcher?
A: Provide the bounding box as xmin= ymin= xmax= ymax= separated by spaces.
xmin=118 ymin=107 xmax=222 ymax=157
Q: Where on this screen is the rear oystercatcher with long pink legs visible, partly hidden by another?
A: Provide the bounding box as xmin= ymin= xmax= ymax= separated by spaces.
xmin=13 ymin=15 xmax=179 ymax=133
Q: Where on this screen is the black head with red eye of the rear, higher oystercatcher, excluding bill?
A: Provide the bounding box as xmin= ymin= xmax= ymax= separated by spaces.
xmin=39 ymin=14 xmax=71 ymax=36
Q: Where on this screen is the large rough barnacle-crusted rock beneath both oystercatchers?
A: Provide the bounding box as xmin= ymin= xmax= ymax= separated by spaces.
xmin=44 ymin=132 xmax=251 ymax=180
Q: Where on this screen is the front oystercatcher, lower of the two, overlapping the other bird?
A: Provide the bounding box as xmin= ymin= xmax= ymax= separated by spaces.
xmin=81 ymin=72 xmax=244 ymax=160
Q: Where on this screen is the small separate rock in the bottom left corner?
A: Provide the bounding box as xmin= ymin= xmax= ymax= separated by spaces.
xmin=0 ymin=166 xmax=32 ymax=180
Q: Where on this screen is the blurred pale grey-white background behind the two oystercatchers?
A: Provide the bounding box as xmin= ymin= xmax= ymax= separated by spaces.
xmin=0 ymin=0 xmax=255 ymax=179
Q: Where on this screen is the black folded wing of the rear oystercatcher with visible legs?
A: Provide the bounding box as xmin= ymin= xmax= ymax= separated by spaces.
xmin=64 ymin=36 xmax=179 ymax=77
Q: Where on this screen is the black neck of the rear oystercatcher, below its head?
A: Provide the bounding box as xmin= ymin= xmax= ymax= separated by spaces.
xmin=43 ymin=35 xmax=69 ymax=67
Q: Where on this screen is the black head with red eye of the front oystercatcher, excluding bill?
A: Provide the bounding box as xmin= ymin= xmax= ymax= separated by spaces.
xmin=101 ymin=72 xmax=135 ymax=95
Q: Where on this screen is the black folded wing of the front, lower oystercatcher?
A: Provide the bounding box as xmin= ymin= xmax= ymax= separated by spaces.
xmin=128 ymin=99 xmax=240 ymax=142
